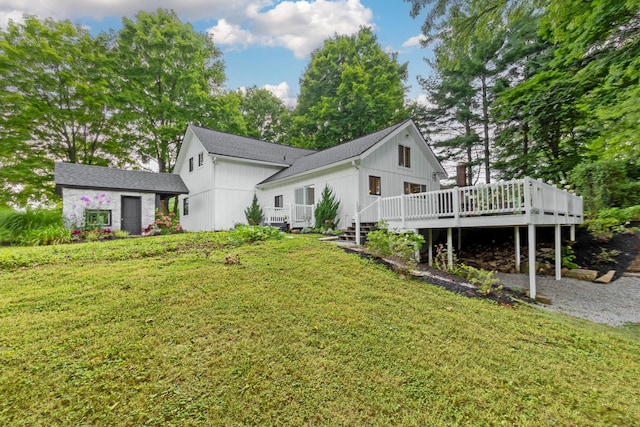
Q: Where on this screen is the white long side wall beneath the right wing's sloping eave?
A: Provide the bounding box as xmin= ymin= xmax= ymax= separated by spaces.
xmin=258 ymin=164 xmax=358 ymax=228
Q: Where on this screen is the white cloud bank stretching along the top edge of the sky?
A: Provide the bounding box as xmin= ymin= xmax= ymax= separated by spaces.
xmin=0 ymin=0 xmax=373 ymax=58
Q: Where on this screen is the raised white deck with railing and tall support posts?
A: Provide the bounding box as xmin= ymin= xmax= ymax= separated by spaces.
xmin=355 ymin=177 xmax=583 ymax=298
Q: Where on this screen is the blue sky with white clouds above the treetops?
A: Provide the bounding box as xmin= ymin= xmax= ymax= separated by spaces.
xmin=0 ymin=0 xmax=431 ymax=105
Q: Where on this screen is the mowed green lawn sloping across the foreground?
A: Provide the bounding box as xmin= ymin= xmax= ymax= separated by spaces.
xmin=0 ymin=233 xmax=640 ymax=426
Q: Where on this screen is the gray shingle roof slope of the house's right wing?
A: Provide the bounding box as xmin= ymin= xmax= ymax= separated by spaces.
xmin=260 ymin=121 xmax=407 ymax=184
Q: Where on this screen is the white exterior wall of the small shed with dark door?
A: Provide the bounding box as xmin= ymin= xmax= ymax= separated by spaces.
xmin=62 ymin=188 xmax=156 ymax=230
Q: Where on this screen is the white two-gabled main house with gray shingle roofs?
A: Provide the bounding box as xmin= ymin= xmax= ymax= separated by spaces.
xmin=174 ymin=120 xmax=446 ymax=231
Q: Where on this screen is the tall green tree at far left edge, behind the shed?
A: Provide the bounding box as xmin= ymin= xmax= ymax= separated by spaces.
xmin=0 ymin=16 xmax=124 ymax=205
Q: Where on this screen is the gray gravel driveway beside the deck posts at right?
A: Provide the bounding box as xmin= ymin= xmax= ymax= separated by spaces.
xmin=496 ymin=273 xmax=640 ymax=326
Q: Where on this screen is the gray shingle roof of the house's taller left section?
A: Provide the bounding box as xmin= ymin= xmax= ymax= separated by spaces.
xmin=189 ymin=125 xmax=316 ymax=165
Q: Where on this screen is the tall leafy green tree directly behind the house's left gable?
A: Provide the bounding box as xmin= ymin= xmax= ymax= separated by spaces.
xmin=116 ymin=9 xmax=226 ymax=172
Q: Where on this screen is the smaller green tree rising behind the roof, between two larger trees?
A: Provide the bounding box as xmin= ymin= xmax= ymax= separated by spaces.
xmin=238 ymin=86 xmax=291 ymax=142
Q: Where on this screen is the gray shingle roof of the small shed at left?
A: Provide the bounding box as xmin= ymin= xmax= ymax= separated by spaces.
xmin=54 ymin=163 xmax=189 ymax=194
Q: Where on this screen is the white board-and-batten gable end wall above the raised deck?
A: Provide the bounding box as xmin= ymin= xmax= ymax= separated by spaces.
xmin=359 ymin=128 xmax=440 ymax=222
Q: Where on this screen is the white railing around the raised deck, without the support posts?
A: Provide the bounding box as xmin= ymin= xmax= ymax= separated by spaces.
xmin=358 ymin=178 xmax=582 ymax=231
